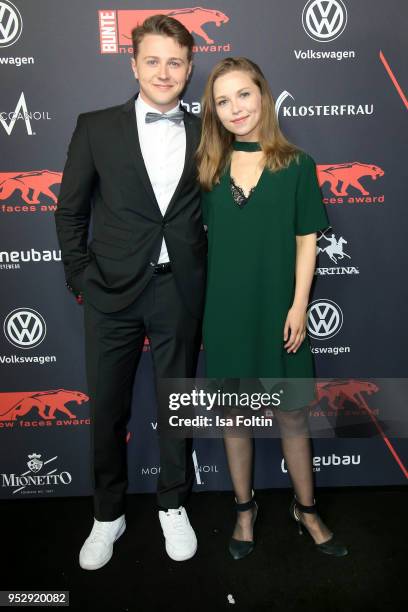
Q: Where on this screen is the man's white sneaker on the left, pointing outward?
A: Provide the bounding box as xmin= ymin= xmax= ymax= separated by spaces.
xmin=79 ymin=514 xmax=126 ymax=570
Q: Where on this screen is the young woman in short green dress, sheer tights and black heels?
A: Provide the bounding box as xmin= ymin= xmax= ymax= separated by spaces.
xmin=197 ymin=58 xmax=347 ymax=559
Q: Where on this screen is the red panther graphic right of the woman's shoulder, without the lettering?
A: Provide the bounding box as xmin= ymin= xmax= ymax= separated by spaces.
xmin=317 ymin=162 xmax=384 ymax=196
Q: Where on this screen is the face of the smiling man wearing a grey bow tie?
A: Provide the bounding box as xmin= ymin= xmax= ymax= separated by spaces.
xmin=132 ymin=34 xmax=192 ymax=113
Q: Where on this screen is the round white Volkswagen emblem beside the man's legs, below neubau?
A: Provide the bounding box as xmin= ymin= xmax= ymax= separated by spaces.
xmin=3 ymin=308 xmax=47 ymax=349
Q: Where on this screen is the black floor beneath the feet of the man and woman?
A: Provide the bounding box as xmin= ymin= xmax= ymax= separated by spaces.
xmin=0 ymin=487 xmax=408 ymax=612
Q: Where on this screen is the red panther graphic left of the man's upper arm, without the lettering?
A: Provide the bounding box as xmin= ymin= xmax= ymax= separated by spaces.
xmin=0 ymin=170 xmax=62 ymax=204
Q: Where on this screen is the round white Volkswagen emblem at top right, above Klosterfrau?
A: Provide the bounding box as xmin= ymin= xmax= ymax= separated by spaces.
xmin=302 ymin=0 xmax=347 ymax=42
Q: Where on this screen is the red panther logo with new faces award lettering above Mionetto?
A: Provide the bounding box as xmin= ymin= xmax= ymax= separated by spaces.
xmin=0 ymin=389 xmax=89 ymax=427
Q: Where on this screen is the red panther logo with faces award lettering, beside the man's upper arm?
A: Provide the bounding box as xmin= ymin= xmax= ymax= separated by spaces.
xmin=0 ymin=170 xmax=62 ymax=212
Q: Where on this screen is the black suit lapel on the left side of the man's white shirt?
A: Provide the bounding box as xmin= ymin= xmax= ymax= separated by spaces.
xmin=121 ymin=96 xmax=162 ymax=217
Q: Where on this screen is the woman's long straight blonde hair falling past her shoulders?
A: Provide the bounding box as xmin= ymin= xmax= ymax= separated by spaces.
xmin=196 ymin=57 xmax=299 ymax=190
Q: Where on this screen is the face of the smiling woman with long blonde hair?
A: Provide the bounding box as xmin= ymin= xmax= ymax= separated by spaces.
xmin=213 ymin=70 xmax=262 ymax=141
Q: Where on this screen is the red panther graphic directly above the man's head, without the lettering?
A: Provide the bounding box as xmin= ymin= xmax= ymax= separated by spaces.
xmin=117 ymin=6 xmax=229 ymax=46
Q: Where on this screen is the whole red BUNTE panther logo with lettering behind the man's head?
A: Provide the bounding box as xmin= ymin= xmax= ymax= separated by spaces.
xmin=99 ymin=6 xmax=231 ymax=54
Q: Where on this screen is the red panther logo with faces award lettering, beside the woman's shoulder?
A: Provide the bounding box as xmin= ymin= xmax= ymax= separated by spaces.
xmin=317 ymin=162 xmax=384 ymax=204
